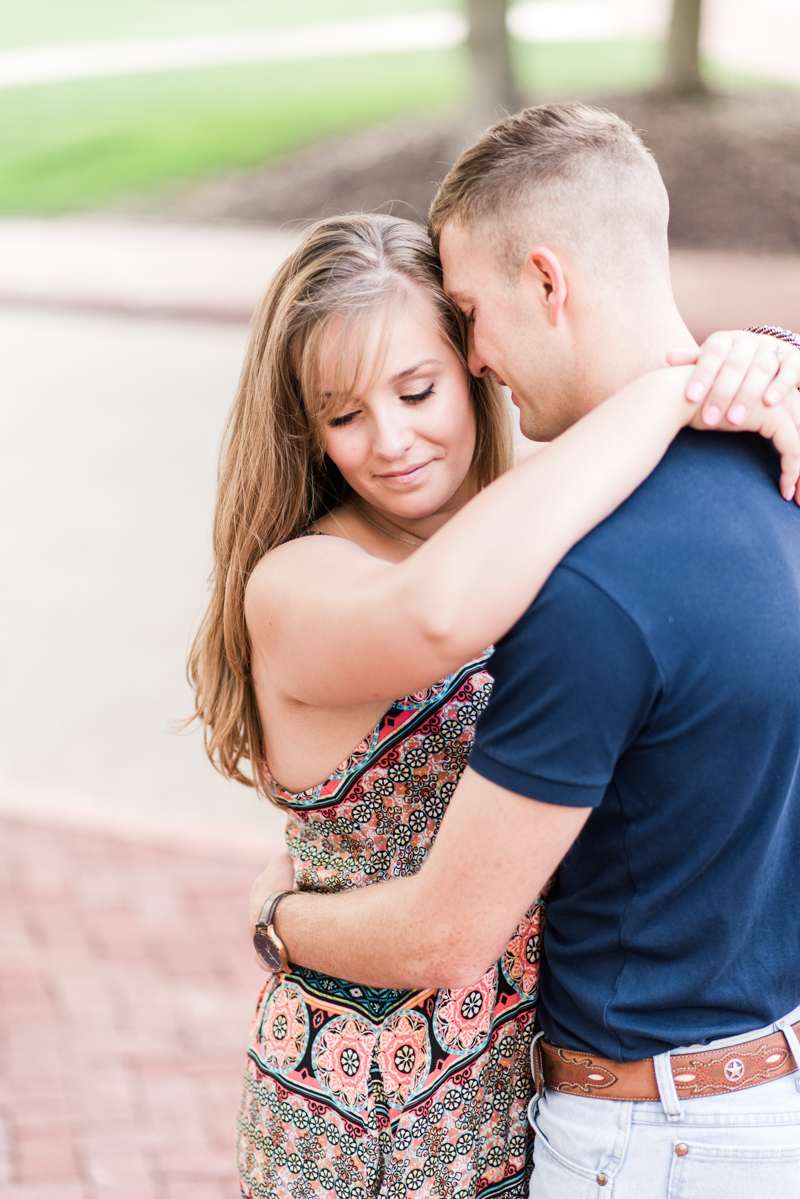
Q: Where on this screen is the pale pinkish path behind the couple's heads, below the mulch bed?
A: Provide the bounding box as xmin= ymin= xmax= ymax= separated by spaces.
xmin=0 ymin=217 xmax=800 ymax=338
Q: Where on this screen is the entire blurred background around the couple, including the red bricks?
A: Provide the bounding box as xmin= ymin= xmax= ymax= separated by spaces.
xmin=0 ymin=0 xmax=800 ymax=1199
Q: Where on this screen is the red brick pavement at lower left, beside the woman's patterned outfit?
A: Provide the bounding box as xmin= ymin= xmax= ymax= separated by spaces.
xmin=0 ymin=819 xmax=275 ymax=1199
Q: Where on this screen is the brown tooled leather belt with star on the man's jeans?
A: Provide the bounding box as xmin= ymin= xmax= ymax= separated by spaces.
xmin=534 ymin=1022 xmax=800 ymax=1102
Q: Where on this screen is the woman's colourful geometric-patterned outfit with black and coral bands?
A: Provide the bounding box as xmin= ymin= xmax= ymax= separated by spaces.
xmin=237 ymin=652 xmax=545 ymax=1199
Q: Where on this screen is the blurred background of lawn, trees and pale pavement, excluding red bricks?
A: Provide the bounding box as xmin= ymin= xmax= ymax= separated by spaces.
xmin=0 ymin=0 xmax=800 ymax=836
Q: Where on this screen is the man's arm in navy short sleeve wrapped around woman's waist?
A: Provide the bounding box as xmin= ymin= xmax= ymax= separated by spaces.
xmin=251 ymin=568 xmax=661 ymax=989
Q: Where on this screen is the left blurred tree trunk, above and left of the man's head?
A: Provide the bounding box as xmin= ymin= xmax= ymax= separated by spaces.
xmin=467 ymin=0 xmax=518 ymax=129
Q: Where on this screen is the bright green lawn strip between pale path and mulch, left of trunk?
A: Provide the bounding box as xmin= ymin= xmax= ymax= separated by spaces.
xmin=0 ymin=52 xmax=465 ymax=213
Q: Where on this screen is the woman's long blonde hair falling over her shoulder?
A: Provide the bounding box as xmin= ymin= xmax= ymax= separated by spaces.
xmin=187 ymin=215 xmax=511 ymax=795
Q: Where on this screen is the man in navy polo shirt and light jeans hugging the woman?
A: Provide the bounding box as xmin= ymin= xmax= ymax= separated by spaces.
xmin=253 ymin=106 xmax=800 ymax=1199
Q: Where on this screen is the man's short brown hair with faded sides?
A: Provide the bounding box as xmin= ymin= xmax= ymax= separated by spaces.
xmin=428 ymin=103 xmax=669 ymax=280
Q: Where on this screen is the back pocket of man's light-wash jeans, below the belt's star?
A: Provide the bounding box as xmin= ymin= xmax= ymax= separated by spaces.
xmin=669 ymin=1140 xmax=800 ymax=1199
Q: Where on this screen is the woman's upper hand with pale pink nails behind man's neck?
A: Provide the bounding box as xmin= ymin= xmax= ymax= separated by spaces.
xmin=667 ymin=330 xmax=800 ymax=436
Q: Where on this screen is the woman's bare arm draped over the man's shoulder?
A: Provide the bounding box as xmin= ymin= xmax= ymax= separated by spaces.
xmin=246 ymin=359 xmax=800 ymax=707
